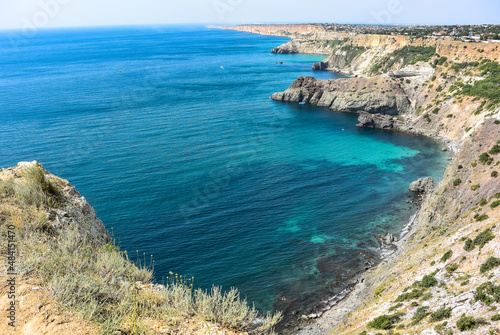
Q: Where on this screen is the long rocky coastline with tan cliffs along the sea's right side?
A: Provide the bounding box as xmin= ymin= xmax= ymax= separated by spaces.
xmin=214 ymin=24 xmax=500 ymax=334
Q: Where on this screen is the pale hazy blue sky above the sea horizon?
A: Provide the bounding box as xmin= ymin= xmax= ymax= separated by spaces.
xmin=0 ymin=0 xmax=500 ymax=29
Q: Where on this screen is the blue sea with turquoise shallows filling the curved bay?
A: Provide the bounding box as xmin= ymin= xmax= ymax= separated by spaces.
xmin=0 ymin=26 xmax=447 ymax=318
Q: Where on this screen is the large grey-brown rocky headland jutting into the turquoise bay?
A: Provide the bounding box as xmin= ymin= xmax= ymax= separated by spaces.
xmin=271 ymin=76 xmax=413 ymax=115
